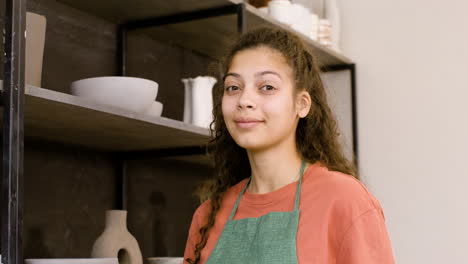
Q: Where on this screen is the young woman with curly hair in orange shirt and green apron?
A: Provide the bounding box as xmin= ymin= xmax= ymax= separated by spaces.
xmin=184 ymin=28 xmax=394 ymax=264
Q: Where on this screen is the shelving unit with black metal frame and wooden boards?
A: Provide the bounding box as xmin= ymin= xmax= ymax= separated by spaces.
xmin=1 ymin=0 xmax=357 ymax=264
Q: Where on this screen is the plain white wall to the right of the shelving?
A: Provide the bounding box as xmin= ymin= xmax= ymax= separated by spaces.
xmin=338 ymin=0 xmax=468 ymax=264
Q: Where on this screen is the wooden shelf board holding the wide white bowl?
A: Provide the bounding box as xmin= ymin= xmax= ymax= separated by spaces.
xmin=2 ymin=85 xmax=210 ymax=151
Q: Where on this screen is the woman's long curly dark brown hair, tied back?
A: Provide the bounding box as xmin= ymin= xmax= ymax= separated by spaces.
xmin=185 ymin=28 xmax=359 ymax=264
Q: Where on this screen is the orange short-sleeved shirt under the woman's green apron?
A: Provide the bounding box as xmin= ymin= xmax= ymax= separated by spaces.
xmin=184 ymin=162 xmax=395 ymax=264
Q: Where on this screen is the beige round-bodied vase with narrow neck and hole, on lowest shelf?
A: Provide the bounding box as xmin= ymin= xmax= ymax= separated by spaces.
xmin=91 ymin=210 xmax=143 ymax=264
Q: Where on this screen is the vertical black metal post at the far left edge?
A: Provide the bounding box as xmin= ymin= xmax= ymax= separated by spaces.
xmin=1 ymin=0 xmax=26 ymax=264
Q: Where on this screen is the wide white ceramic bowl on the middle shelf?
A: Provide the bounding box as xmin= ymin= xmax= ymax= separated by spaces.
xmin=70 ymin=76 xmax=158 ymax=113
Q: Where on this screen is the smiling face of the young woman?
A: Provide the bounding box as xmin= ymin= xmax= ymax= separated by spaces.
xmin=222 ymin=46 xmax=299 ymax=150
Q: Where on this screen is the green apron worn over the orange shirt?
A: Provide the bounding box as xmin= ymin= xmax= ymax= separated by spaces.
xmin=206 ymin=161 xmax=305 ymax=264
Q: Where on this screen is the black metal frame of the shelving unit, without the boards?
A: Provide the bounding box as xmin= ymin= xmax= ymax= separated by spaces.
xmin=1 ymin=0 xmax=358 ymax=264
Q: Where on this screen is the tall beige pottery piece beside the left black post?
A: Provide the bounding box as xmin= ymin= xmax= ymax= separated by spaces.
xmin=25 ymin=12 xmax=46 ymax=87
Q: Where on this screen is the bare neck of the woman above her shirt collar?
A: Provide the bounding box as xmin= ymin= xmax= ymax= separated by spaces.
xmin=247 ymin=140 xmax=308 ymax=194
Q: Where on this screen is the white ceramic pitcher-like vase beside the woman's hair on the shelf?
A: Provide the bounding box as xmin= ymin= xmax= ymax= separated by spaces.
xmin=182 ymin=76 xmax=217 ymax=128
